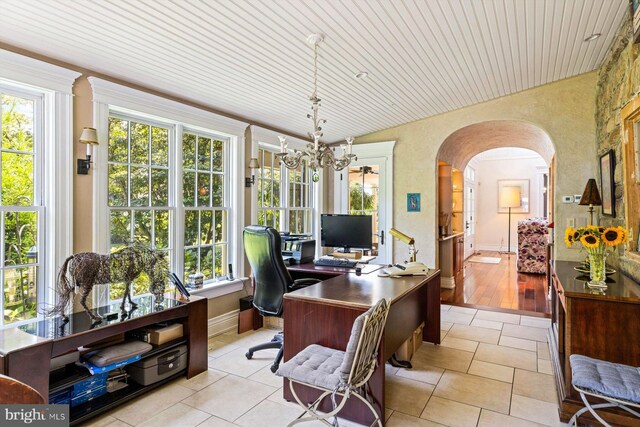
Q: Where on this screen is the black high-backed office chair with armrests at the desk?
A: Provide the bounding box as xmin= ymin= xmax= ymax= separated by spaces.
xmin=242 ymin=225 xmax=319 ymax=372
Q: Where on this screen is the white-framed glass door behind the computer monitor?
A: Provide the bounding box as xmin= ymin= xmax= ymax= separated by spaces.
xmin=334 ymin=142 xmax=395 ymax=264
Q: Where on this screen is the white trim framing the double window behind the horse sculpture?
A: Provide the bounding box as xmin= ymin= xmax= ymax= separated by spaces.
xmin=88 ymin=77 xmax=248 ymax=286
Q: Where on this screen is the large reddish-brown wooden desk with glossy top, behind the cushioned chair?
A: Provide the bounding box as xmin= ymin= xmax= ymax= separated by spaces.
xmin=283 ymin=267 xmax=440 ymax=425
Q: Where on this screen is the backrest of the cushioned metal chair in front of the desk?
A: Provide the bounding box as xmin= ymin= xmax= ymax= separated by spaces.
xmin=340 ymin=299 xmax=391 ymax=387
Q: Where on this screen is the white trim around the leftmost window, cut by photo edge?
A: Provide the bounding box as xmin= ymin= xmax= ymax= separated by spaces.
xmin=0 ymin=50 xmax=81 ymax=324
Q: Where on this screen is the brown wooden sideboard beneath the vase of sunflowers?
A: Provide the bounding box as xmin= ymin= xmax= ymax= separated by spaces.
xmin=549 ymin=261 xmax=640 ymax=426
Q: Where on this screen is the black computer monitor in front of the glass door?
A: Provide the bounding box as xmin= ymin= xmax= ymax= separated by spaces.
xmin=320 ymin=214 xmax=373 ymax=252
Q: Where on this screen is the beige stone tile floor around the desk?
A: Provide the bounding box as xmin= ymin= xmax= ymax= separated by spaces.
xmin=86 ymin=305 xmax=563 ymax=427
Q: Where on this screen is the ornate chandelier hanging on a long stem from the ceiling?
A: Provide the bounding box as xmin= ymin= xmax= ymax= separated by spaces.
xmin=276 ymin=34 xmax=357 ymax=182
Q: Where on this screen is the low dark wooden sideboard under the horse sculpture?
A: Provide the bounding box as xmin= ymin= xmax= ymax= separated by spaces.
xmin=0 ymin=296 xmax=208 ymax=425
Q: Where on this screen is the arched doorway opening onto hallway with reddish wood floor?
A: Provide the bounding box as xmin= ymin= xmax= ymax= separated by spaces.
xmin=436 ymin=120 xmax=555 ymax=314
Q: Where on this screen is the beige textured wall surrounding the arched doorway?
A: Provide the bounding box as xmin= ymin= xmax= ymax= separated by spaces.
xmin=356 ymin=72 xmax=596 ymax=266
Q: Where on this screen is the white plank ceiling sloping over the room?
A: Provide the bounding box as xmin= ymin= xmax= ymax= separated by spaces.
xmin=0 ymin=0 xmax=629 ymax=141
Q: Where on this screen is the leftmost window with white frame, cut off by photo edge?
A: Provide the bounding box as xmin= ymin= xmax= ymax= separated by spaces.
xmin=0 ymin=49 xmax=80 ymax=329
